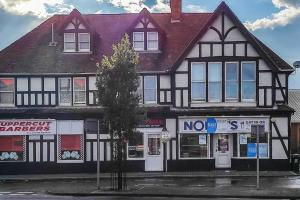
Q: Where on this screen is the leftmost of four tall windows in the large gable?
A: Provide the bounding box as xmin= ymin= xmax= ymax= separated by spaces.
xmin=191 ymin=63 xmax=206 ymax=101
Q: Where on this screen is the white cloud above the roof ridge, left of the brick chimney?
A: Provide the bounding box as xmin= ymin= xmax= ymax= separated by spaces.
xmin=97 ymin=0 xmax=170 ymax=13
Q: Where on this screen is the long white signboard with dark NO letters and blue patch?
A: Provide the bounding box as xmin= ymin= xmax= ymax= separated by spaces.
xmin=179 ymin=117 xmax=270 ymax=133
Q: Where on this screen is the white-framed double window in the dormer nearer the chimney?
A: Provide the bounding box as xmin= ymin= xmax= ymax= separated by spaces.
xmin=133 ymin=31 xmax=159 ymax=51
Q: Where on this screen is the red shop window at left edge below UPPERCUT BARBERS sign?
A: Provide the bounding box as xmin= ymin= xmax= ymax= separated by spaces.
xmin=0 ymin=136 xmax=25 ymax=161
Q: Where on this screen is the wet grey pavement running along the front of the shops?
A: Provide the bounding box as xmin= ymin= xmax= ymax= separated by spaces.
xmin=0 ymin=170 xmax=300 ymax=199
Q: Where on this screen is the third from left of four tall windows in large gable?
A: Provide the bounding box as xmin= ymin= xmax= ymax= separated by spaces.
xmin=225 ymin=63 xmax=239 ymax=101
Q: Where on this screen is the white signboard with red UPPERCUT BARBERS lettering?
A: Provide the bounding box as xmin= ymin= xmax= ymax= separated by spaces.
xmin=0 ymin=119 xmax=56 ymax=135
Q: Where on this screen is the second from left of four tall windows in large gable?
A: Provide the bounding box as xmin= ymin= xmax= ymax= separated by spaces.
xmin=208 ymin=63 xmax=222 ymax=102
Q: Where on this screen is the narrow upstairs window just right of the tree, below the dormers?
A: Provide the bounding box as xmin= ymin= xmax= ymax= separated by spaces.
xmin=144 ymin=76 xmax=157 ymax=103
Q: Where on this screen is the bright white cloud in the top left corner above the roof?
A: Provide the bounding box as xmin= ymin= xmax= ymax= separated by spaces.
xmin=0 ymin=0 xmax=73 ymax=18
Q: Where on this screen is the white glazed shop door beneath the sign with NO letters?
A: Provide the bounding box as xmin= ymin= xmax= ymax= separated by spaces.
xmin=215 ymin=134 xmax=231 ymax=168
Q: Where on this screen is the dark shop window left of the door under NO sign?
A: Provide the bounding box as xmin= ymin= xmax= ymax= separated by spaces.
xmin=180 ymin=133 xmax=208 ymax=158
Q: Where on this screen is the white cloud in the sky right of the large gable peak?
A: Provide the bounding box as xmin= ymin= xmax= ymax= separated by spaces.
xmin=245 ymin=0 xmax=300 ymax=31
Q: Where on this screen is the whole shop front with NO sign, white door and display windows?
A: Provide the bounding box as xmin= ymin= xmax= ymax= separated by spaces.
xmin=178 ymin=117 xmax=270 ymax=169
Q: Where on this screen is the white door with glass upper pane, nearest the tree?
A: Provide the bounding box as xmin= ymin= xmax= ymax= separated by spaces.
xmin=145 ymin=133 xmax=163 ymax=171
